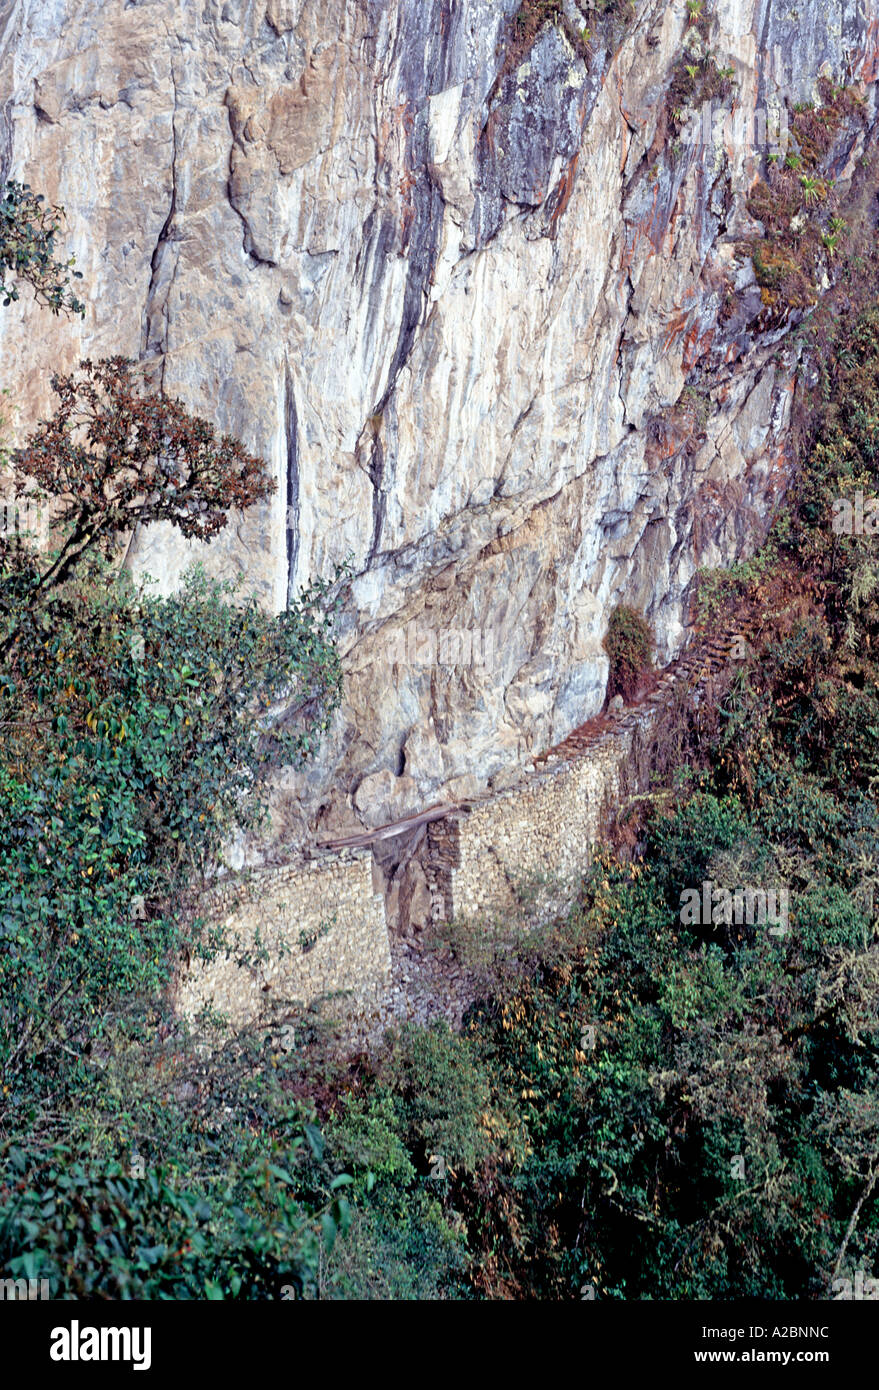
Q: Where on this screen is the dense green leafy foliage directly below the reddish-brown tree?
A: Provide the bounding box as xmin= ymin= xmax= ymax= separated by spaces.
xmin=0 ymin=566 xmax=349 ymax=1081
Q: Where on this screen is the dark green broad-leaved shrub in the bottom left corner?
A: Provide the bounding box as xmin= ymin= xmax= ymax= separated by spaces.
xmin=0 ymin=1145 xmax=321 ymax=1300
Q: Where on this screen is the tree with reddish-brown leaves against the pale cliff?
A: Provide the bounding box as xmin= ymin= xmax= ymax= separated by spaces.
xmin=13 ymin=357 xmax=275 ymax=596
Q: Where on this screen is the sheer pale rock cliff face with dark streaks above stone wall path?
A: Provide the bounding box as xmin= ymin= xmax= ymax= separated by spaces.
xmin=0 ymin=0 xmax=879 ymax=841
